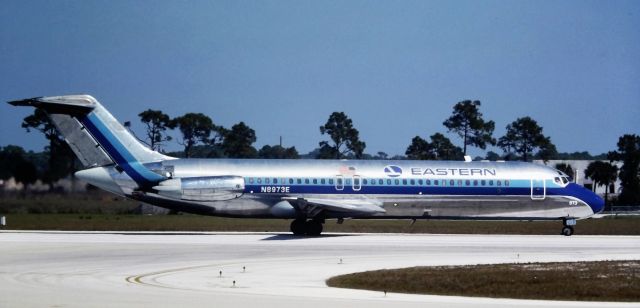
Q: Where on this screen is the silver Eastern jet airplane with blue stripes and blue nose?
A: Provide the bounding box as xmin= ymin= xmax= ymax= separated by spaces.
xmin=9 ymin=95 xmax=604 ymax=236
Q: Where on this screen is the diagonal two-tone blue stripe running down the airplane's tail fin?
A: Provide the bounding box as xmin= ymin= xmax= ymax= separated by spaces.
xmin=80 ymin=112 xmax=165 ymax=187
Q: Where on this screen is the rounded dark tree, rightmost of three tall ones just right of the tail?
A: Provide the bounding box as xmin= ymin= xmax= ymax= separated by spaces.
xmin=222 ymin=122 xmax=258 ymax=158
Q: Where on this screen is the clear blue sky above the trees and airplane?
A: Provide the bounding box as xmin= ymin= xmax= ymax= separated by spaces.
xmin=0 ymin=1 xmax=640 ymax=155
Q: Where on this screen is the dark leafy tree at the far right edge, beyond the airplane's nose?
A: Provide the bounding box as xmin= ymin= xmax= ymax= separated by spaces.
xmin=607 ymin=134 xmax=640 ymax=204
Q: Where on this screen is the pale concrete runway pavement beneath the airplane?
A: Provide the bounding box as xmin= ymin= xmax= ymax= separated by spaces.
xmin=0 ymin=231 xmax=640 ymax=308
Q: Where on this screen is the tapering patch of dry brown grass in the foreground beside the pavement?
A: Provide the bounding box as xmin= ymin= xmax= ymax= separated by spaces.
xmin=327 ymin=261 xmax=640 ymax=301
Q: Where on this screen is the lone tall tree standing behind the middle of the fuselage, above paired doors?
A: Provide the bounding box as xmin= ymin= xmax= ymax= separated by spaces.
xmin=318 ymin=112 xmax=366 ymax=159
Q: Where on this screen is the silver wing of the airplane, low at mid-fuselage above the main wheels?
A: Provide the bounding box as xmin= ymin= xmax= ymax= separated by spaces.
xmin=283 ymin=197 xmax=386 ymax=215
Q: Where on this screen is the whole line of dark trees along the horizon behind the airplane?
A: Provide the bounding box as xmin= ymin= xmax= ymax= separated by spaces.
xmin=0 ymin=100 xmax=640 ymax=203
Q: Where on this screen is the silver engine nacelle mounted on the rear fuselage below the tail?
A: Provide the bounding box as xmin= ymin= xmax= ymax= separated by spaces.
xmin=153 ymin=175 xmax=244 ymax=201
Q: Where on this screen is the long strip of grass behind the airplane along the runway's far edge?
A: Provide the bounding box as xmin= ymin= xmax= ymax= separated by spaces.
xmin=1 ymin=213 xmax=640 ymax=235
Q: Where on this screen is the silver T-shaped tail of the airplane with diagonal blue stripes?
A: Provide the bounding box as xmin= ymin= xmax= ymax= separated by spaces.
xmin=9 ymin=95 xmax=172 ymax=188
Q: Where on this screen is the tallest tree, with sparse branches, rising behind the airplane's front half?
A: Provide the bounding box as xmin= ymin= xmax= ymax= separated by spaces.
xmin=442 ymin=100 xmax=496 ymax=156
